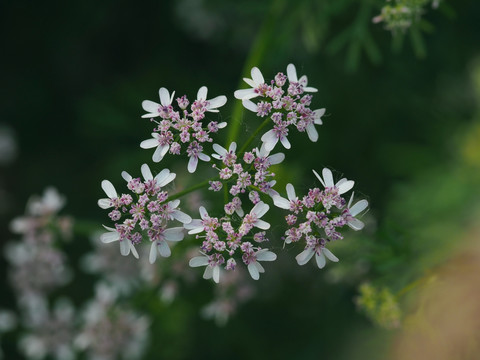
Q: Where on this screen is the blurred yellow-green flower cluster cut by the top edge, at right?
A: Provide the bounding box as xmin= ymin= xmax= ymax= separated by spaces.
xmin=373 ymin=0 xmax=440 ymax=33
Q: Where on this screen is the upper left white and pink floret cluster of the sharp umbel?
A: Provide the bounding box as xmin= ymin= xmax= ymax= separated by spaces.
xmin=140 ymin=86 xmax=227 ymax=173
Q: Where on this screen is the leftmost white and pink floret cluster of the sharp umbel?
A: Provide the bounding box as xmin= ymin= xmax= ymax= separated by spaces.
xmin=98 ymin=164 xmax=192 ymax=263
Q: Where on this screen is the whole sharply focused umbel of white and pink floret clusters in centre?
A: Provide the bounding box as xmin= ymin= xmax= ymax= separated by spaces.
xmin=98 ymin=64 xmax=368 ymax=283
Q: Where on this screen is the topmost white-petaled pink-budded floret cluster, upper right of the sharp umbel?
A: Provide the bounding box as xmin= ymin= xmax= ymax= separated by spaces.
xmin=235 ymin=64 xmax=325 ymax=151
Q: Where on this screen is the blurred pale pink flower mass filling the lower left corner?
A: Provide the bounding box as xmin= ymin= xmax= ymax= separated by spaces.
xmin=0 ymin=188 xmax=149 ymax=360
